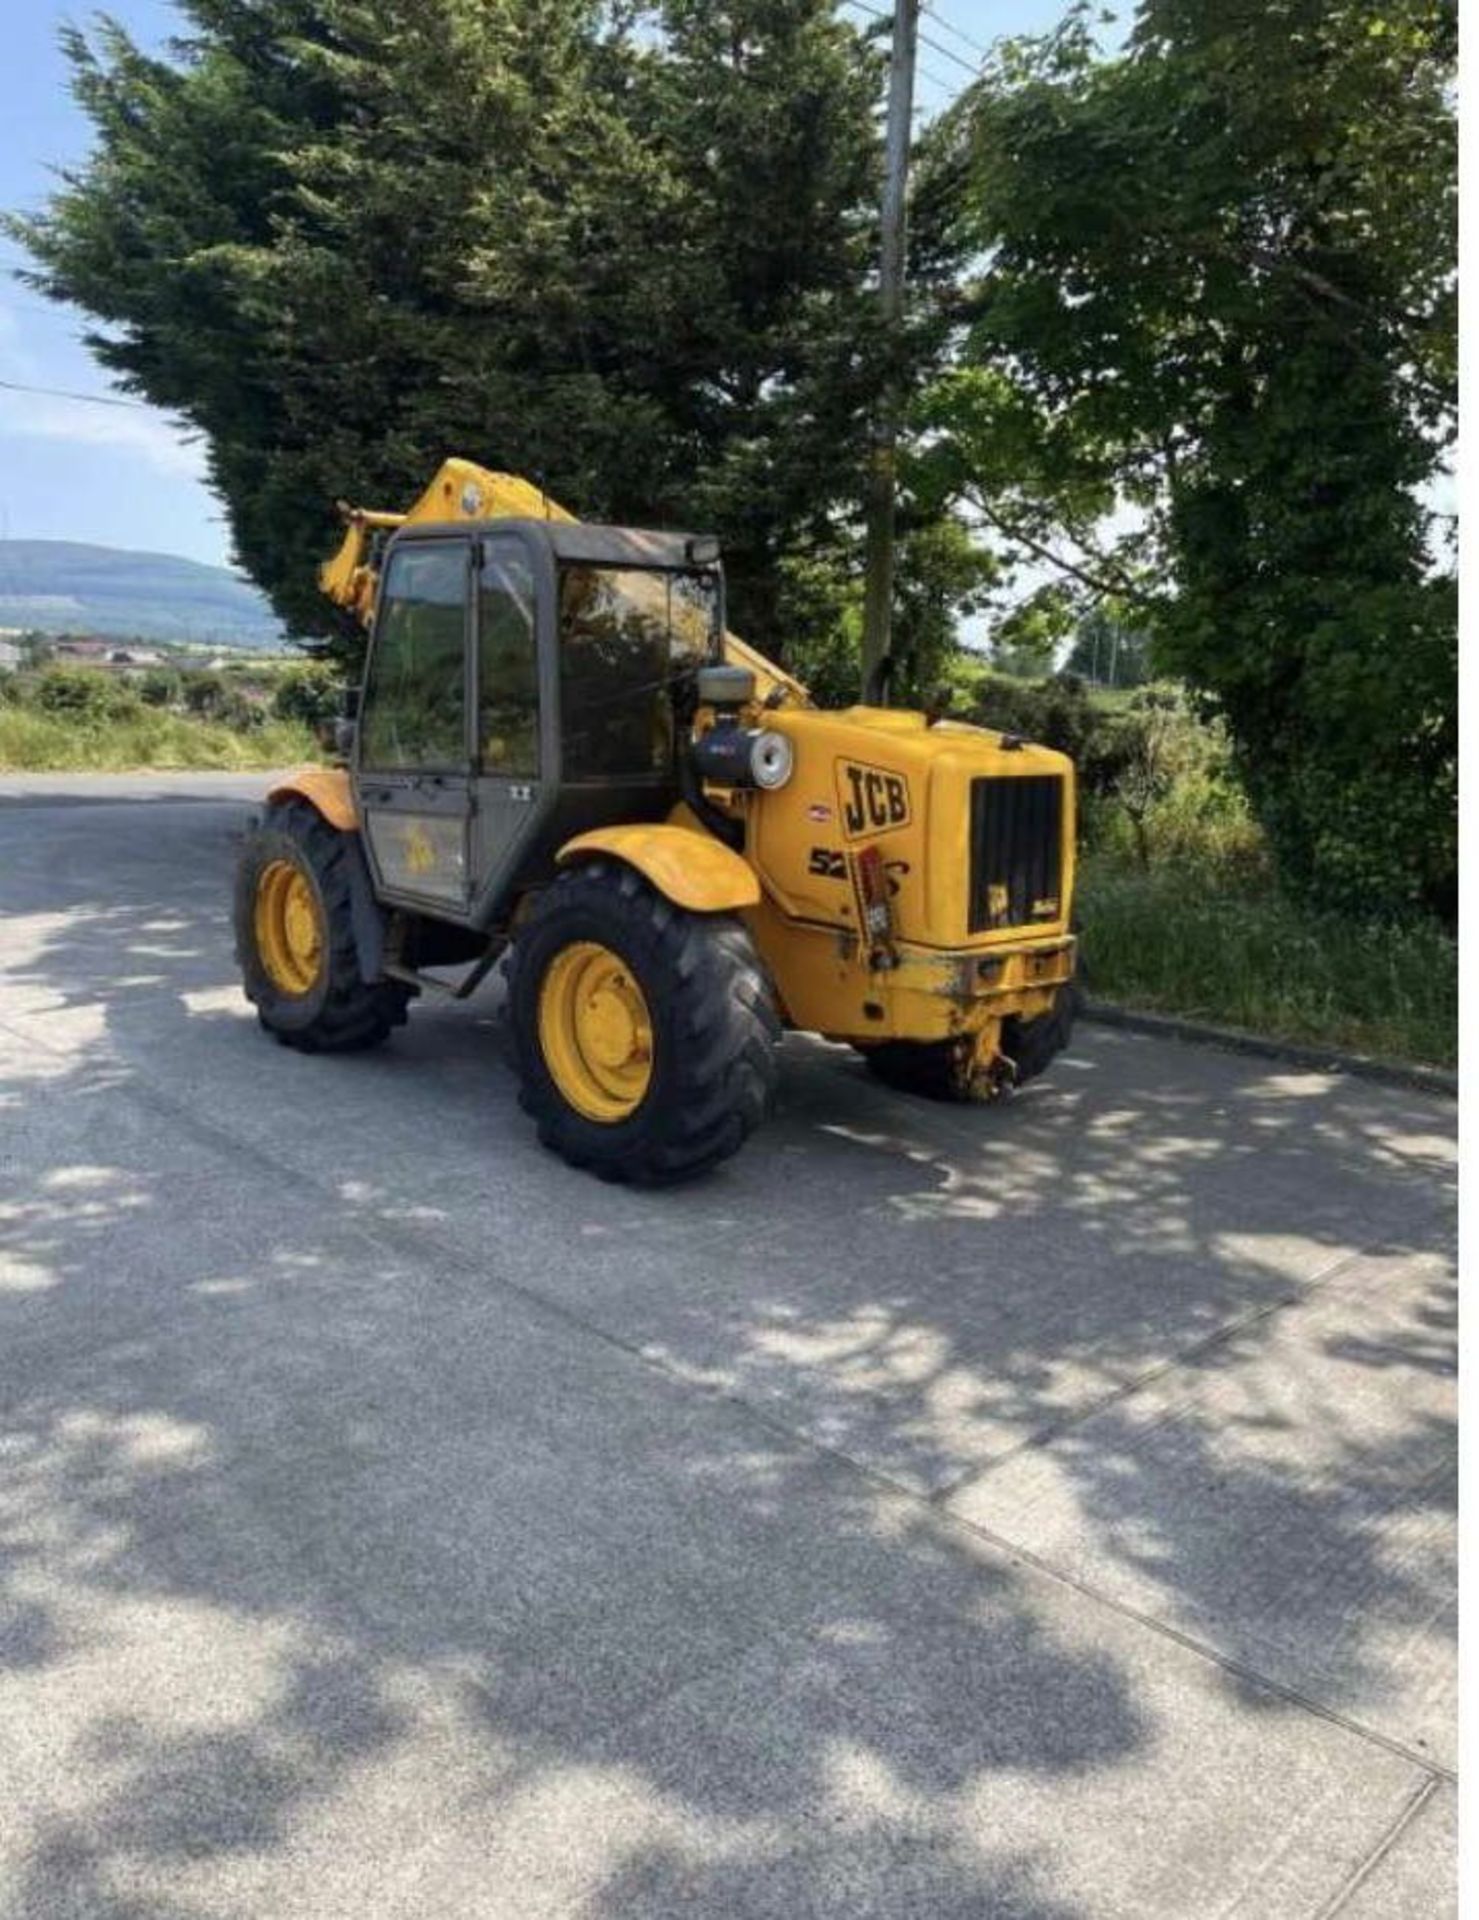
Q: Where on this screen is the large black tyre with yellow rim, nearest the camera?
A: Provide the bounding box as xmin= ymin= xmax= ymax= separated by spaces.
xmin=507 ymin=860 xmax=780 ymax=1187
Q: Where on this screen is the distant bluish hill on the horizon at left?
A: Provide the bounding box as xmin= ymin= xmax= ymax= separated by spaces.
xmin=0 ymin=540 xmax=286 ymax=647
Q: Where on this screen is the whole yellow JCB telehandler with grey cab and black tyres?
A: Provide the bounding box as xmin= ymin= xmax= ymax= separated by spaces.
xmin=236 ymin=459 xmax=1074 ymax=1183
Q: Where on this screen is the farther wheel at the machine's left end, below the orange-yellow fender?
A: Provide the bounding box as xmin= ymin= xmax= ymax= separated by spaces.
xmin=236 ymin=801 xmax=411 ymax=1054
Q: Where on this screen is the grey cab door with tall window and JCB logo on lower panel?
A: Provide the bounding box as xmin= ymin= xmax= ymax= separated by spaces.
xmin=355 ymin=534 xmax=474 ymax=920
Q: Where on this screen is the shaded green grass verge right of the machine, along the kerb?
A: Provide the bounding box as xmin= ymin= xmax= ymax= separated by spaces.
xmin=1078 ymin=854 xmax=1458 ymax=1068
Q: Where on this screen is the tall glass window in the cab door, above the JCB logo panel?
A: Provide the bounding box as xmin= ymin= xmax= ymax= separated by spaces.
xmin=361 ymin=540 xmax=469 ymax=770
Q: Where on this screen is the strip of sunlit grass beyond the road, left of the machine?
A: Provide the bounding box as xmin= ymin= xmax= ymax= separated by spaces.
xmin=0 ymin=707 xmax=319 ymax=774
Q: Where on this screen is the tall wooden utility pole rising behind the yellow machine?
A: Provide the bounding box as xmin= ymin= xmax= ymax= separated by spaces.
xmin=862 ymin=0 xmax=920 ymax=701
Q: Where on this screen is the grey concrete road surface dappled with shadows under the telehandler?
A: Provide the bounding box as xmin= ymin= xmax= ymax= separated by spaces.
xmin=0 ymin=776 xmax=1456 ymax=1920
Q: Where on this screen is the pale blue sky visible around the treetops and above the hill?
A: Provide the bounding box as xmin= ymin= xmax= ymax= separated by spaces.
xmin=0 ymin=0 xmax=1066 ymax=563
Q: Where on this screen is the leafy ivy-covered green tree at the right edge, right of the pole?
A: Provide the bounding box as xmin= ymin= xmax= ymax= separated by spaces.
xmin=926 ymin=0 xmax=1456 ymax=910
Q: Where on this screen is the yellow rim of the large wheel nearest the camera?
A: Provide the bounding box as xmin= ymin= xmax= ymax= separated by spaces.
xmin=540 ymin=941 xmax=653 ymax=1125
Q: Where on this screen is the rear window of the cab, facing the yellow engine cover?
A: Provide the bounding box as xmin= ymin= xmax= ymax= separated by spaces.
xmin=559 ymin=566 xmax=718 ymax=780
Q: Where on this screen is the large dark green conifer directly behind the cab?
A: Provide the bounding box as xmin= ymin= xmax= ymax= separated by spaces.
xmin=10 ymin=0 xmax=979 ymax=679
